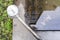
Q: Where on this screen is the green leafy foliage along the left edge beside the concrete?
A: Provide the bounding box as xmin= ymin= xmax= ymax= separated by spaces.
xmin=0 ymin=0 xmax=13 ymax=40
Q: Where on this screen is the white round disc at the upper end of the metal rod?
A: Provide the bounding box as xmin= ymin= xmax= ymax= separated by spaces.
xmin=7 ymin=5 xmax=18 ymax=16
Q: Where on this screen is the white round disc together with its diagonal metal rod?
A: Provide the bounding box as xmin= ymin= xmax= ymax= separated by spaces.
xmin=7 ymin=5 xmax=40 ymax=39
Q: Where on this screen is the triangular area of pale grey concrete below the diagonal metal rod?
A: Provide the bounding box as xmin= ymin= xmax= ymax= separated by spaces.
xmin=13 ymin=18 xmax=37 ymax=40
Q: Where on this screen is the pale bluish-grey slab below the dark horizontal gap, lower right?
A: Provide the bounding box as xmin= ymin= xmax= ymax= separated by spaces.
xmin=36 ymin=31 xmax=60 ymax=40
